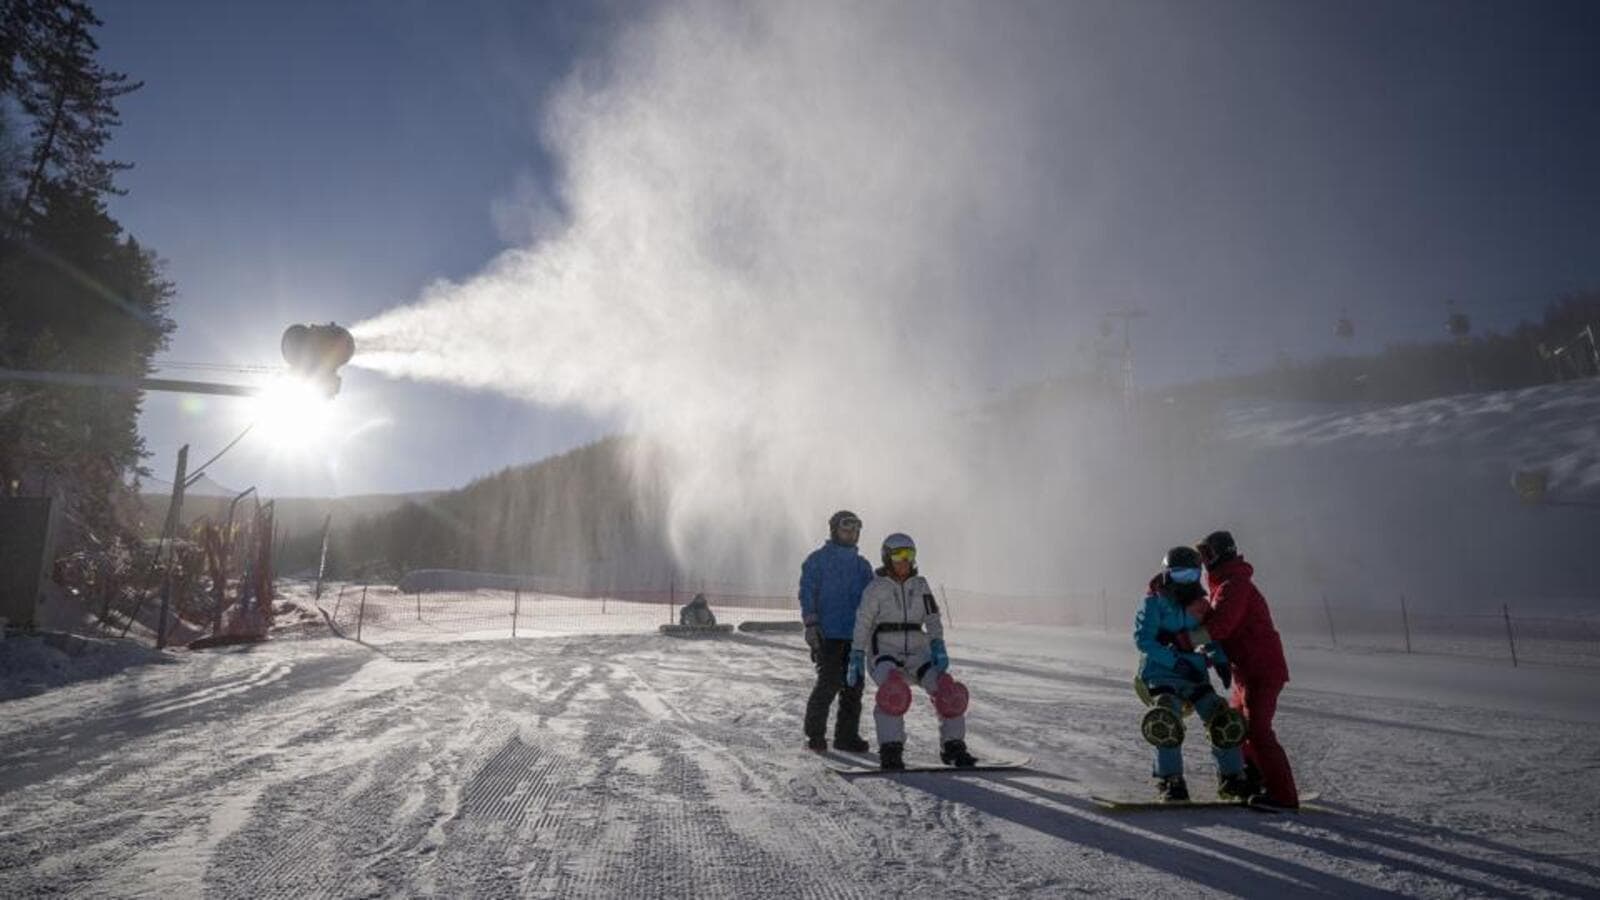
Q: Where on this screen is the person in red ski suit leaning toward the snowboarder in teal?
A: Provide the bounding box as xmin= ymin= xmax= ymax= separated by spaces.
xmin=1195 ymin=532 xmax=1299 ymax=809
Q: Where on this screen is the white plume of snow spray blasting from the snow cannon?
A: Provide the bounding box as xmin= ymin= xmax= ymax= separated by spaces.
xmin=354 ymin=2 xmax=1107 ymax=583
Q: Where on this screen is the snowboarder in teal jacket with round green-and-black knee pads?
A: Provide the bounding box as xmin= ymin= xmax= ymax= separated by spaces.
xmin=1133 ymin=546 xmax=1251 ymax=802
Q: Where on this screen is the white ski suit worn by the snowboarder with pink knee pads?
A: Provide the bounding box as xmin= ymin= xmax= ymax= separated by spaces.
xmin=851 ymin=569 xmax=966 ymax=745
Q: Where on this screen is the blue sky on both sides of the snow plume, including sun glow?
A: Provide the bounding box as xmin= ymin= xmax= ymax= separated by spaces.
xmin=99 ymin=0 xmax=1600 ymax=495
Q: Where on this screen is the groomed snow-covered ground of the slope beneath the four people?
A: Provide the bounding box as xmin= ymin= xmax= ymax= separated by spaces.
xmin=0 ymin=589 xmax=1600 ymax=898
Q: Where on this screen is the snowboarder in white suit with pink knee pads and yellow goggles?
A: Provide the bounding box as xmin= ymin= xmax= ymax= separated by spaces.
xmin=845 ymin=533 xmax=978 ymax=769
